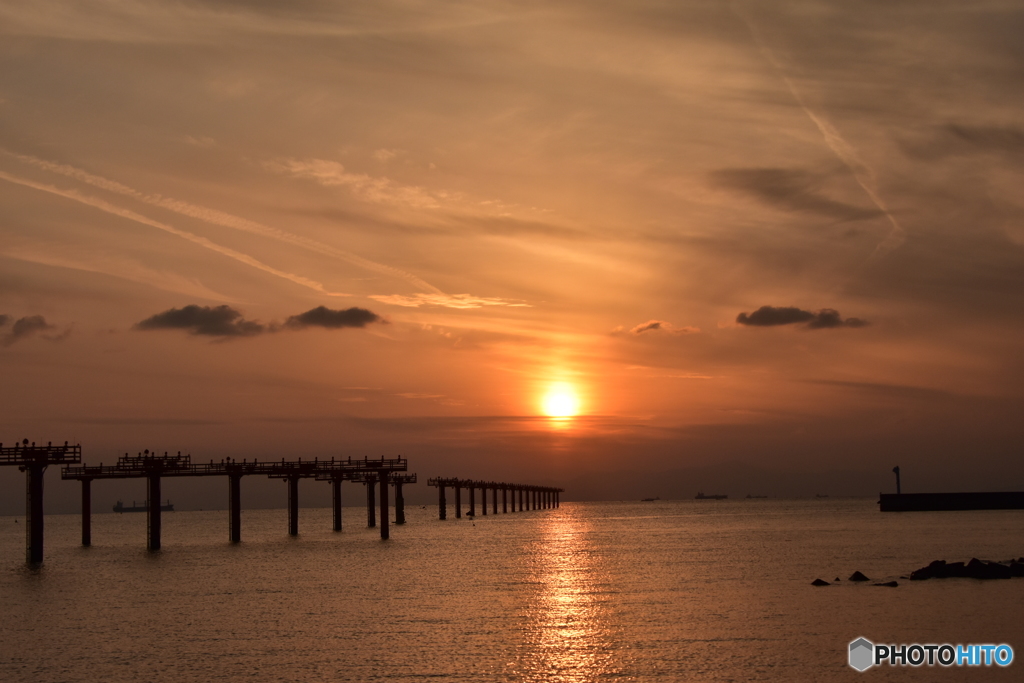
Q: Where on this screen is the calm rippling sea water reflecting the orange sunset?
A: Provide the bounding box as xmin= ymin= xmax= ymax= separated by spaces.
xmin=0 ymin=499 xmax=1024 ymax=683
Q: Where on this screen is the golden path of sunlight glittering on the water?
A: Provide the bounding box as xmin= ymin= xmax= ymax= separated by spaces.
xmin=517 ymin=508 xmax=622 ymax=683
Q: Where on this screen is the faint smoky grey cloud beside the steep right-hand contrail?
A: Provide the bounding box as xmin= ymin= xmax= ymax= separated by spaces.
xmin=712 ymin=168 xmax=883 ymax=221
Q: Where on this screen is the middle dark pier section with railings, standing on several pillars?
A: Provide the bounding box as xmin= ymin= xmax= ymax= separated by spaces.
xmin=60 ymin=451 xmax=407 ymax=550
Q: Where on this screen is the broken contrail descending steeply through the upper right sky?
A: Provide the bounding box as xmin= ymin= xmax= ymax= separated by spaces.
xmin=729 ymin=2 xmax=906 ymax=261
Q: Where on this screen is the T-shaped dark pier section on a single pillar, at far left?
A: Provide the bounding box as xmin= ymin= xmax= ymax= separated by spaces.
xmin=0 ymin=439 xmax=82 ymax=564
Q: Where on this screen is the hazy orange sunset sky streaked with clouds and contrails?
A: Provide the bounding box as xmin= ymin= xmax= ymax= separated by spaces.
xmin=0 ymin=0 xmax=1024 ymax=510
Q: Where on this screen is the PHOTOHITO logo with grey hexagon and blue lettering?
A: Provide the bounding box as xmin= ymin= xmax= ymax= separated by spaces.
xmin=849 ymin=638 xmax=1014 ymax=671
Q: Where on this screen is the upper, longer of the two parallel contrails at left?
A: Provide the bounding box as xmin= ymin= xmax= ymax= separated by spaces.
xmin=0 ymin=148 xmax=443 ymax=295
